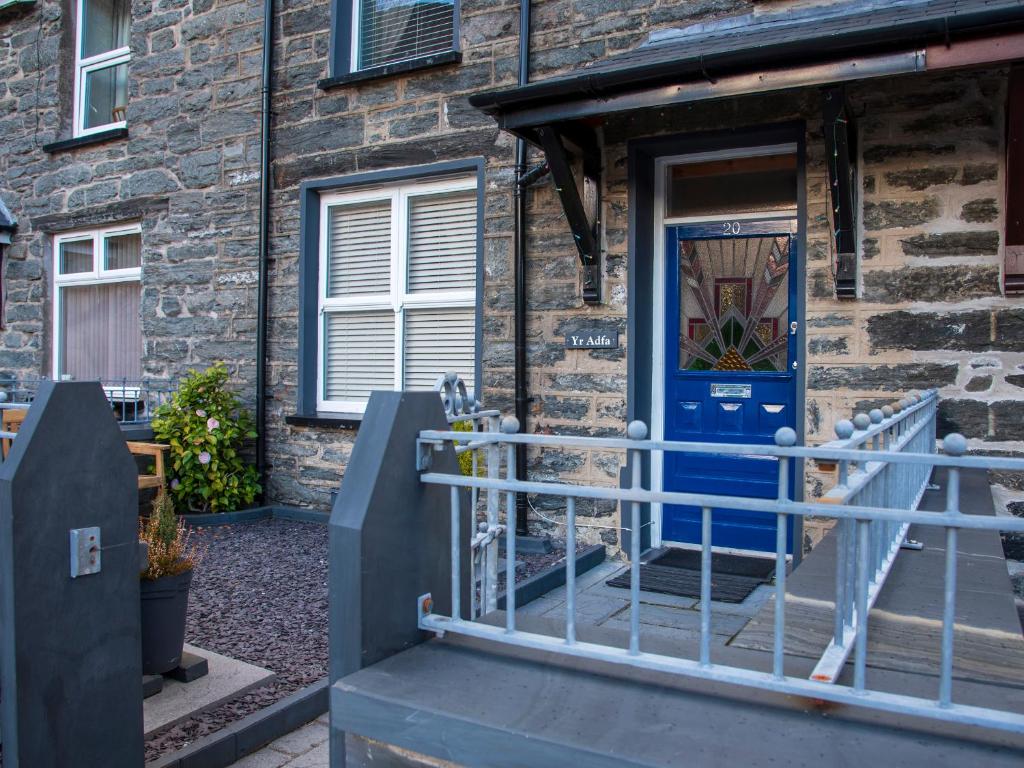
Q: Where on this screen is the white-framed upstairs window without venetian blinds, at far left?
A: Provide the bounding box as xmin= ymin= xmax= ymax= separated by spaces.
xmin=75 ymin=0 xmax=131 ymax=136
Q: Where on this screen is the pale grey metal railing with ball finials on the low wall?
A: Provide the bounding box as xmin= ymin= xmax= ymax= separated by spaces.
xmin=417 ymin=392 xmax=1024 ymax=733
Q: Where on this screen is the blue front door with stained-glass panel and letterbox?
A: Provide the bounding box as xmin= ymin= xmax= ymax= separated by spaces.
xmin=662 ymin=220 xmax=799 ymax=553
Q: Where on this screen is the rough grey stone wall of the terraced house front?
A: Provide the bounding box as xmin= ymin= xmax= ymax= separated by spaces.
xmin=0 ymin=0 xmax=1024 ymax=546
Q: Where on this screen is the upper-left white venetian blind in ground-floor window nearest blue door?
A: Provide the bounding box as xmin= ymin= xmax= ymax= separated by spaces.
xmin=327 ymin=200 xmax=391 ymax=299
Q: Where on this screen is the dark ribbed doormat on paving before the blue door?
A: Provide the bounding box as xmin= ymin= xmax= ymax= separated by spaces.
xmin=605 ymin=549 xmax=775 ymax=603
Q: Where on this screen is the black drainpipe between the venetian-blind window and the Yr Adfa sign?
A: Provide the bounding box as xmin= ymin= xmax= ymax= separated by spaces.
xmin=512 ymin=0 xmax=529 ymax=536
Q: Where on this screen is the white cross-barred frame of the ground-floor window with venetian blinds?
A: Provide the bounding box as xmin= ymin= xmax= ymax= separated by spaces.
xmin=316 ymin=176 xmax=475 ymax=414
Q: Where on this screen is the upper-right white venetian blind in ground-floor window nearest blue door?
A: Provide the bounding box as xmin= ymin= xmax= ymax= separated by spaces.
xmin=409 ymin=190 xmax=477 ymax=293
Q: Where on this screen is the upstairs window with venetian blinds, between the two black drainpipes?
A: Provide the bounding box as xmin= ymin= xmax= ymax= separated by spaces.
xmin=354 ymin=0 xmax=456 ymax=70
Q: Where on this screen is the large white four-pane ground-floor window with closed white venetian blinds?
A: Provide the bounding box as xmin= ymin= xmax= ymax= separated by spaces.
xmin=317 ymin=179 xmax=479 ymax=413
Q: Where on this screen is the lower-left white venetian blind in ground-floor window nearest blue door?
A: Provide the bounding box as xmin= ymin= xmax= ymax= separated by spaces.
xmin=324 ymin=310 xmax=394 ymax=401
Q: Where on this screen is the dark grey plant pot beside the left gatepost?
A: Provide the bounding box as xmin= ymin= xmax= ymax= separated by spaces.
xmin=139 ymin=570 xmax=193 ymax=675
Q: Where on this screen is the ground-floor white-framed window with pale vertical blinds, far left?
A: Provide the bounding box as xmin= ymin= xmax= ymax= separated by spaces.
xmin=53 ymin=225 xmax=142 ymax=383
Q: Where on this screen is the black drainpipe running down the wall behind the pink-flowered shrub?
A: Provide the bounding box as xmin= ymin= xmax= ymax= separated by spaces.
xmin=256 ymin=0 xmax=273 ymax=504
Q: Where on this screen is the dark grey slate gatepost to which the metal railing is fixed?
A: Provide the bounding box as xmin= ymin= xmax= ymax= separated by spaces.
xmin=329 ymin=392 xmax=471 ymax=768
